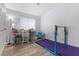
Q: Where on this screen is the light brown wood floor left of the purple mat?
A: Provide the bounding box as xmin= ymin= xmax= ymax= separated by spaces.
xmin=2 ymin=43 xmax=52 ymax=56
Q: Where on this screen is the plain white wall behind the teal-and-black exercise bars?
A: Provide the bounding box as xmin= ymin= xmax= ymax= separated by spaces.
xmin=41 ymin=4 xmax=79 ymax=47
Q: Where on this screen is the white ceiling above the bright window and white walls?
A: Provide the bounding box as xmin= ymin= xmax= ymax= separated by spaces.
xmin=5 ymin=3 xmax=61 ymax=16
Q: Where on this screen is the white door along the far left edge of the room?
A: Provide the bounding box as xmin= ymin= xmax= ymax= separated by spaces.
xmin=0 ymin=4 xmax=6 ymax=55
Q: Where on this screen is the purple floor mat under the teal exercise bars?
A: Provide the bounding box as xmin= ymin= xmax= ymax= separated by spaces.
xmin=36 ymin=39 xmax=79 ymax=56
